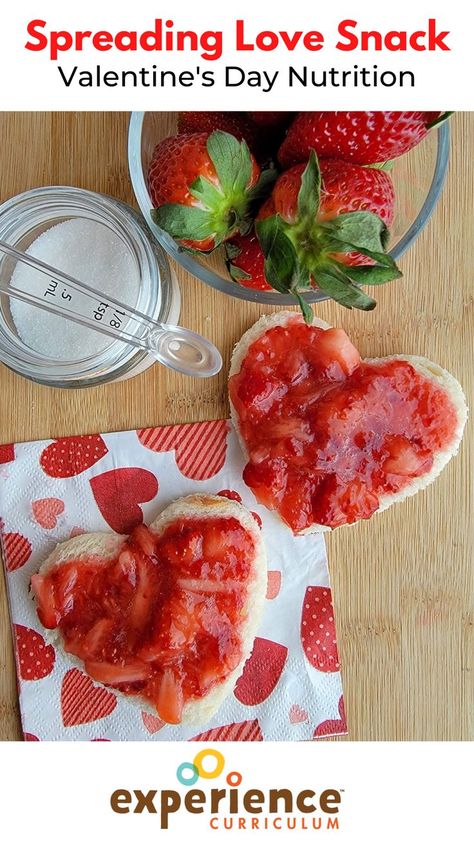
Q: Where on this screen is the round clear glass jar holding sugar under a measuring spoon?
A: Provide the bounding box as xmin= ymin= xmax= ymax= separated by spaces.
xmin=0 ymin=187 xmax=180 ymax=388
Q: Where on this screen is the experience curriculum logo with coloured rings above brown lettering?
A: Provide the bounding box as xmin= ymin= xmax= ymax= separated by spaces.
xmin=110 ymin=748 xmax=343 ymax=830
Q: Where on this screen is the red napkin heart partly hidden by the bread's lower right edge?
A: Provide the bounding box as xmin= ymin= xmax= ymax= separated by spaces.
xmin=234 ymin=637 xmax=288 ymax=705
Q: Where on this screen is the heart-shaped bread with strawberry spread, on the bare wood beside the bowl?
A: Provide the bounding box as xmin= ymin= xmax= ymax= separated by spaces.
xmin=229 ymin=311 xmax=467 ymax=534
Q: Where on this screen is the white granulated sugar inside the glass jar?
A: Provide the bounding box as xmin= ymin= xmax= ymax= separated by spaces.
xmin=10 ymin=219 xmax=140 ymax=361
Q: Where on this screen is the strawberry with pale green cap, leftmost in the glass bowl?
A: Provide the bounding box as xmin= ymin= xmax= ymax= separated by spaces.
xmin=148 ymin=131 xmax=268 ymax=252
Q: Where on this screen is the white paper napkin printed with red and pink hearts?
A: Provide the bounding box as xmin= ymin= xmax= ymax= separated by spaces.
xmin=0 ymin=421 xmax=347 ymax=740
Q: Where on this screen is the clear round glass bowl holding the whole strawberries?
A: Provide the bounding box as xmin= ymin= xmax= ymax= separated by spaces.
xmin=128 ymin=111 xmax=449 ymax=305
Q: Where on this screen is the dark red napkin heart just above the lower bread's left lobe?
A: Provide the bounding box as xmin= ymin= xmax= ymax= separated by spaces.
xmin=90 ymin=468 xmax=158 ymax=535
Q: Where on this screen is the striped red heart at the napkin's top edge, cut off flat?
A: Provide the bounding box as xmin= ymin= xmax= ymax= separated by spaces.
xmin=137 ymin=421 xmax=229 ymax=480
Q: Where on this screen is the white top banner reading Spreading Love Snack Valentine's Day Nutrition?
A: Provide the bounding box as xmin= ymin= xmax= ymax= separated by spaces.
xmin=0 ymin=0 xmax=474 ymax=111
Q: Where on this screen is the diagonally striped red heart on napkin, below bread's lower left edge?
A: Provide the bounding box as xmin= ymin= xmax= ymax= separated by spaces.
xmin=61 ymin=668 xmax=117 ymax=728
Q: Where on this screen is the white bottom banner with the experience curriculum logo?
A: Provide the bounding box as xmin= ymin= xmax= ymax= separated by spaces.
xmin=0 ymin=742 xmax=472 ymax=842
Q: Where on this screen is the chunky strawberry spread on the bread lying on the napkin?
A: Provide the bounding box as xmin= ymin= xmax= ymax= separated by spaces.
xmin=31 ymin=517 xmax=255 ymax=723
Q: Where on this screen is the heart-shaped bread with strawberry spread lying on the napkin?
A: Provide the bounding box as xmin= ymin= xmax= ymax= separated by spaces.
xmin=31 ymin=494 xmax=267 ymax=725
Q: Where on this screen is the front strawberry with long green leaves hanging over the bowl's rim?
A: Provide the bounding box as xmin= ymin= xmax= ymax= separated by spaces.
xmin=255 ymin=152 xmax=401 ymax=321
